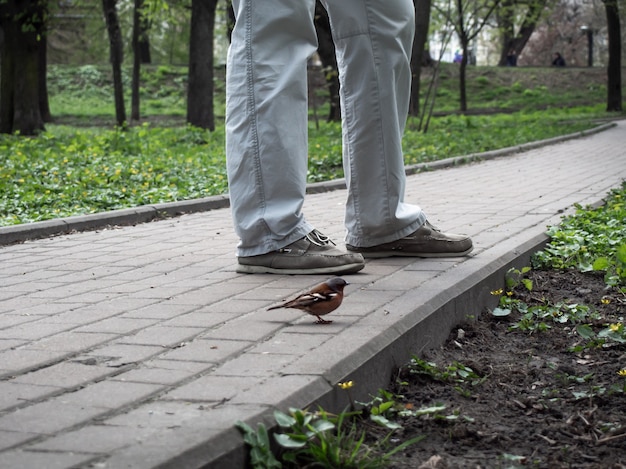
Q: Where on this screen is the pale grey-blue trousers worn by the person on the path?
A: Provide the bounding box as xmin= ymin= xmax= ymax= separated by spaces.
xmin=226 ymin=0 xmax=426 ymax=256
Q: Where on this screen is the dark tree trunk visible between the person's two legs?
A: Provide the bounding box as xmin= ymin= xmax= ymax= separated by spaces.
xmin=315 ymin=0 xmax=341 ymax=122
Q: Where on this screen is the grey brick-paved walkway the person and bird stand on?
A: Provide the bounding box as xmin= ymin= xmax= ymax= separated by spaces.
xmin=0 ymin=121 xmax=626 ymax=469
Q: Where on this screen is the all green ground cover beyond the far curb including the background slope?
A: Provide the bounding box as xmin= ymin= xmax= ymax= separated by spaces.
xmin=0 ymin=64 xmax=615 ymax=226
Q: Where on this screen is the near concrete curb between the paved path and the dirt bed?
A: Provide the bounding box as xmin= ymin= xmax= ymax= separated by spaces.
xmin=165 ymin=221 xmax=558 ymax=469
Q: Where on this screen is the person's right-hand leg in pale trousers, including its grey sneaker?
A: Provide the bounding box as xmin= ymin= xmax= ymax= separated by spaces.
xmin=324 ymin=0 xmax=471 ymax=257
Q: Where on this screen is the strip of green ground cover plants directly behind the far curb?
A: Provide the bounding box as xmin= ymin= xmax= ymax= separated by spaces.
xmin=0 ymin=110 xmax=594 ymax=226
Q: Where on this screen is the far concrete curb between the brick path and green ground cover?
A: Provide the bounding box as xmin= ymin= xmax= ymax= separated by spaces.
xmin=0 ymin=123 xmax=615 ymax=246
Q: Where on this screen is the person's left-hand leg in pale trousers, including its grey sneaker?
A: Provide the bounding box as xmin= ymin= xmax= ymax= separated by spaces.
xmin=226 ymin=0 xmax=364 ymax=274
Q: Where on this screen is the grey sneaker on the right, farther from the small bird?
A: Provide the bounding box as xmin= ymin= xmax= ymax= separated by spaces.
xmin=346 ymin=222 xmax=474 ymax=258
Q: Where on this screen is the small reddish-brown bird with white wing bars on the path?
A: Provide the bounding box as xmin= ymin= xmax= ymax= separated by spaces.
xmin=267 ymin=277 xmax=350 ymax=324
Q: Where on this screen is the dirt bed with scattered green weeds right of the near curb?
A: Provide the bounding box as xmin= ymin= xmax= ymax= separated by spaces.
xmin=380 ymin=186 xmax=626 ymax=469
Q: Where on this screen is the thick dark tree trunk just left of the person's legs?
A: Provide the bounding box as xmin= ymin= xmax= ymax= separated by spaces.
xmin=187 ymin=0 xmax=218 ymax=131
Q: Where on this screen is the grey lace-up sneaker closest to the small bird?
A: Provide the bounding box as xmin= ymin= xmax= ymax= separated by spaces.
xmin=237 ymin=230 xmax=365 ymax=275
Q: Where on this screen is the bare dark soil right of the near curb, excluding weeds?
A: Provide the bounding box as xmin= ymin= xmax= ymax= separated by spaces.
xmin=370 ymin=271 xmax=626 ymax=469
